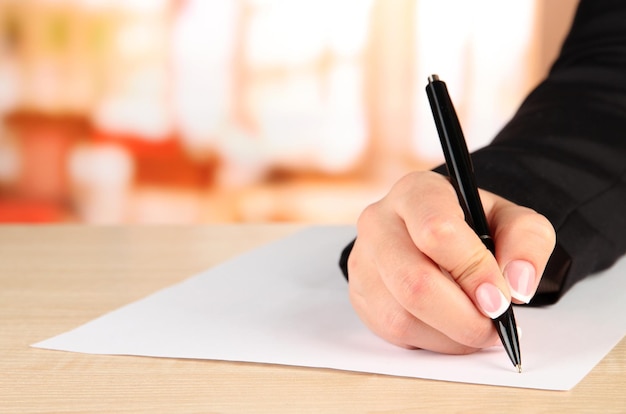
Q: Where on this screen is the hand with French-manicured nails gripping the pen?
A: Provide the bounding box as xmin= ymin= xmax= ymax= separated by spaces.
xmin=348 ymin=171 xmax=556 ymax=354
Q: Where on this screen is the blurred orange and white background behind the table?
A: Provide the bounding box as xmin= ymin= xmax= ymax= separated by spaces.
xmin=0 ymin=0 xmax=576 ymax=224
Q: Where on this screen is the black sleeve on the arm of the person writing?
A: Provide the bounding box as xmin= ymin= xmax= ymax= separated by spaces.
xmin=342 ymin=0 xmax=626 ymax=305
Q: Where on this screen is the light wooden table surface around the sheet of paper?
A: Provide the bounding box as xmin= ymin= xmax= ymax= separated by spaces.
xmin=0 ymin=224 xmax=626 ymax=414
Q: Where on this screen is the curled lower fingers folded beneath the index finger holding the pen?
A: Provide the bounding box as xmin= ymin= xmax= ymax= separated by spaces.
xmin=348 ymin=197 xmax=497 ymax=353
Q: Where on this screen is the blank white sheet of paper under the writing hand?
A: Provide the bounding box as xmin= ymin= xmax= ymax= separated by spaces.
xmin=33 ymin=226 xmax=626 ymax=390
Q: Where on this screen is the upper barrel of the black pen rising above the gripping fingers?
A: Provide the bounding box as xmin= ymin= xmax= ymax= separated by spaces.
xmin=426 ymin=79 xmax=494 ymax=243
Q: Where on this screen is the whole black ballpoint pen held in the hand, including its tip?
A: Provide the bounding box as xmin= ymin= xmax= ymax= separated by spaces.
xmin=426 ymin=75 xmax=522 ymax=372
